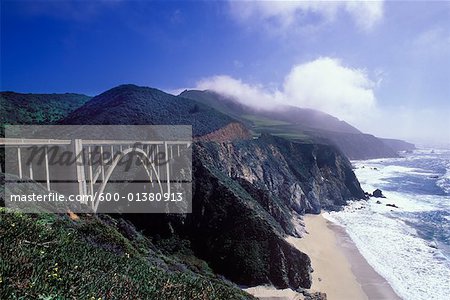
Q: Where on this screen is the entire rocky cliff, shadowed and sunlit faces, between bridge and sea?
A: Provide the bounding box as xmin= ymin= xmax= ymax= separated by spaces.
xmin=171 ymin=135 xmax=364 ymax=289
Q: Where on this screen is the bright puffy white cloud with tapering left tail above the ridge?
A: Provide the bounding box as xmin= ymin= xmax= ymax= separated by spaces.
xmin=197 ymin=57 xmax=376 ymax=122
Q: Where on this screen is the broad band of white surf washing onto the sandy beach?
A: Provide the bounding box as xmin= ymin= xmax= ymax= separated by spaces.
xmin=324 ymin=202 xmax=450 ymax=300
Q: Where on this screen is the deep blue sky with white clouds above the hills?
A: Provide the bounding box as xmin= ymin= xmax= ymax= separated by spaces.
xmin=1 ymin=0 xmax=450 ymax=142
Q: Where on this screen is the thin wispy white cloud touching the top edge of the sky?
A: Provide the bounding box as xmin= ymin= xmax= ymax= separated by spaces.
xmin=230 ymin=0 xmax=384 ymax=33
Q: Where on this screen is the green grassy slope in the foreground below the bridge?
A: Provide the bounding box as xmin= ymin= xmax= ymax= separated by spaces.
xmin=0 ymin=208 xmax=253 ymax=299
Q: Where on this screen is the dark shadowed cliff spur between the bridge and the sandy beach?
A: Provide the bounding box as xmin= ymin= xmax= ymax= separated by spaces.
xmin=188 ymin=159 xmax=312 ymax=289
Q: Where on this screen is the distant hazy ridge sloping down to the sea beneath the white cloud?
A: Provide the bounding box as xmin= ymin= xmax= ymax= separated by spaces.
xmin=180 ymin=90 xmax=415 ymax=159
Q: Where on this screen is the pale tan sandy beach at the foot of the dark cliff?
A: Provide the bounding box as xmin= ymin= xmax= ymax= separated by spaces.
xmin=247 ymin=215 xmax=400 ymax=300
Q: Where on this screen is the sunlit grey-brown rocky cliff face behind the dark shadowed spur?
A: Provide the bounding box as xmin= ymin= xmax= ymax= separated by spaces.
xmin=197 ymin=135 xmax=364 ymax=219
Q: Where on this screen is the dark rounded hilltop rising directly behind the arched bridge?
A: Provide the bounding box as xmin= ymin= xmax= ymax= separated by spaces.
xmin=60 ymin=84 xmax=236 ymax=136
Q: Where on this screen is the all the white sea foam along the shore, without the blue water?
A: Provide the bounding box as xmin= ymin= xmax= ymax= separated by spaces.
xmin=324 ymin=150 xmax=450 ymax=300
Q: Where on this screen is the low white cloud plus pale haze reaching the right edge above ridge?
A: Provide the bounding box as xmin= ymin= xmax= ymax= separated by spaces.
xmin=196 ymin=57 xmax=450 ymax=144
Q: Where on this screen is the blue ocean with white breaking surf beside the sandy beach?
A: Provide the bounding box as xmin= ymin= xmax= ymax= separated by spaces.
xmin=324 ymin=149 xmax=450 ymax=300
